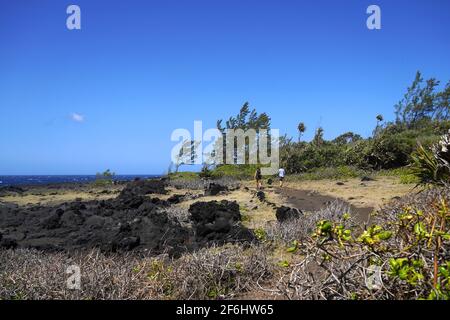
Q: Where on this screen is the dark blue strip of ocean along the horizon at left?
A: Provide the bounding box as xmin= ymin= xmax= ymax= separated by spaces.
xmin=0 ymin=174 xmax=160 ymax=187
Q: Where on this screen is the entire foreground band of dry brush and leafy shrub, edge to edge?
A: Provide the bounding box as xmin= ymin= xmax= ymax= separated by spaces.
xmin=0 ymin=188 xmax=450 ymax=299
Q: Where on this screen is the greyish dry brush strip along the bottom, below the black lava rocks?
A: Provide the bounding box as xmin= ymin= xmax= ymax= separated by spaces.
xmin=0 ymin=245 xmax=271 ymax=300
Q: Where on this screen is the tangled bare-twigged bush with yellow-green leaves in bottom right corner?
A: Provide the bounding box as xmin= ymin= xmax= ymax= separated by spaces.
xmin=270 ymin=189 xmax=450 ymax=299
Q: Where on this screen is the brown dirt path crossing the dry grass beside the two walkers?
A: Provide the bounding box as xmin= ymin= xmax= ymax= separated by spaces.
xmin=275 ymin=187 xmax=374 ymax=223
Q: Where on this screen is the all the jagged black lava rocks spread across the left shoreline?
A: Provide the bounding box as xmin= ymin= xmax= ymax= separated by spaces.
xmin=0 ymin=179 xmax=255 ymax=255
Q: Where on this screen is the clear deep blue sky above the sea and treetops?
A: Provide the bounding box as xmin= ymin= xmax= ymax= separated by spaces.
xmin=0 ymin=0 xmax=450 ymax=175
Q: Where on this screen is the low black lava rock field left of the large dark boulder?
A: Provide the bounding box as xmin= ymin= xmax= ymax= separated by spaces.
xmin=0 ymin=191 xmax=191 ymax=255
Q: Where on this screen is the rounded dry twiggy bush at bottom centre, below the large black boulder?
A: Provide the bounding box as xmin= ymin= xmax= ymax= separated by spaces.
xmin=149 ymin=245 xmax=272 ymax=299
